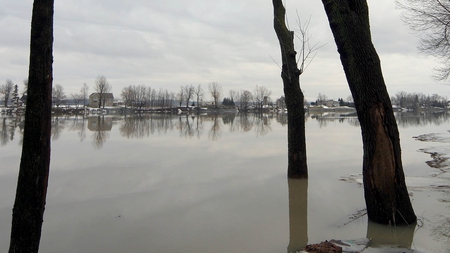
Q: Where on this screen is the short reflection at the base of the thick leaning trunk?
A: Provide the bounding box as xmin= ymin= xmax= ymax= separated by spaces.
xmin=366 ymin=221 xmax=416 ymax=249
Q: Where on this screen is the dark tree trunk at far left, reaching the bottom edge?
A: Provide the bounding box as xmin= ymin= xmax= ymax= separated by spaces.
xmin=9 ymin=0 xmax=53 ymax=253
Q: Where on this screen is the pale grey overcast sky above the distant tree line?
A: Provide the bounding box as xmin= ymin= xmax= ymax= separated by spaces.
xmin=0 ymin=0 xmax=450 ymax=101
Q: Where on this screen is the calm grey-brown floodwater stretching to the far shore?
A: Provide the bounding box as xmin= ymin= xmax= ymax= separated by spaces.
xmin=0 ymin=113 xmax=450 ymax=253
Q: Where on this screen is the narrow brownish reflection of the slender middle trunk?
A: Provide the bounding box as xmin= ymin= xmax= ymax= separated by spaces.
xmin=287 ymin=178 xmax=308 ymax=253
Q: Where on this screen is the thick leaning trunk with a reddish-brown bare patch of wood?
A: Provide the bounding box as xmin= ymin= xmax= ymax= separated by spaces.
xmin=322 ymin=0 xmax=416 ymax=224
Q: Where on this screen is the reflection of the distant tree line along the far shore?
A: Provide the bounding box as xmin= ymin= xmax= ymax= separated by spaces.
xmin=0 ymin=111 xmax=450 ymax=144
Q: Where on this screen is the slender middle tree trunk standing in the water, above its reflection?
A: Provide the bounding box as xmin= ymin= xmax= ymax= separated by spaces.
xmin=272 ymin=0 xmax=308 ymax=178
